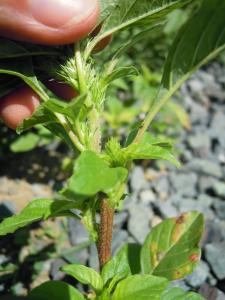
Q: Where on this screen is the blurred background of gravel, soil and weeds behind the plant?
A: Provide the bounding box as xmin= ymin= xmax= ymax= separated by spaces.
xmin=0 ymin=7 xmax=225 ymax=300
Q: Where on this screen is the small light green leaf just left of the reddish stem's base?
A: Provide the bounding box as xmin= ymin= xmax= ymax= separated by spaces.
xmin=62 ymin=264 xmax=103 ymax=292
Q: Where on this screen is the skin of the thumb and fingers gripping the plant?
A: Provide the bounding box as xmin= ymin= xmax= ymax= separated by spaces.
xmin=0 ymin=0 xmax=99 ymax=129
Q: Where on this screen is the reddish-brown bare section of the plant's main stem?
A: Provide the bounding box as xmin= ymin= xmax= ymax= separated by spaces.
xmin=98 ymin=198 xmax=115 ymax=268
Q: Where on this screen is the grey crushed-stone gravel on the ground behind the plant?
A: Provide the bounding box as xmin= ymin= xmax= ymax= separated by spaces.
xmin=0 ymin=63 xmax=225 ymax=300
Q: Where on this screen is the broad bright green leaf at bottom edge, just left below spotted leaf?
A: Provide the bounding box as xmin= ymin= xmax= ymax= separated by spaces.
xmin=112 ymin=275 xmax=168 ymax=300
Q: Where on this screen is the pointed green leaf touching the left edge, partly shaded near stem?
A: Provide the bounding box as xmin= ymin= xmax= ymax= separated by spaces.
xmin=0 ymin=199 xmax=75 ymax=236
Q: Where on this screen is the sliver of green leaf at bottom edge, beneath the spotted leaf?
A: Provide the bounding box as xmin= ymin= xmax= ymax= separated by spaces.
xmin=162 ymin=287 xmax=205 ymax=300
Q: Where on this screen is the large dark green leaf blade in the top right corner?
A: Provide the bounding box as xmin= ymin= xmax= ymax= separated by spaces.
xmin=162 ymin=0 xmax=225 ymax=89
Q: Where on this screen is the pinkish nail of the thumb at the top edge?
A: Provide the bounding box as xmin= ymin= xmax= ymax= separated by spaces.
xmin=29 ymin=0 xmax=97 ymax=28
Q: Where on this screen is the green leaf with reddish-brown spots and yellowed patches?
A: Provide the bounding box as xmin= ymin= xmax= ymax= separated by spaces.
xmin=141 ymin=212 xmax=204 ymax=280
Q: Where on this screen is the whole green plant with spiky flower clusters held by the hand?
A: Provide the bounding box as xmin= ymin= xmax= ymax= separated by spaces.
xmin=0 ymin=0 xmax=225 ymax=300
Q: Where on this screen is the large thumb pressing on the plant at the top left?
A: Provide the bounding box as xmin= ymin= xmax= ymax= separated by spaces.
xmin=0 ymin=0 xmax=99 ymax=45
